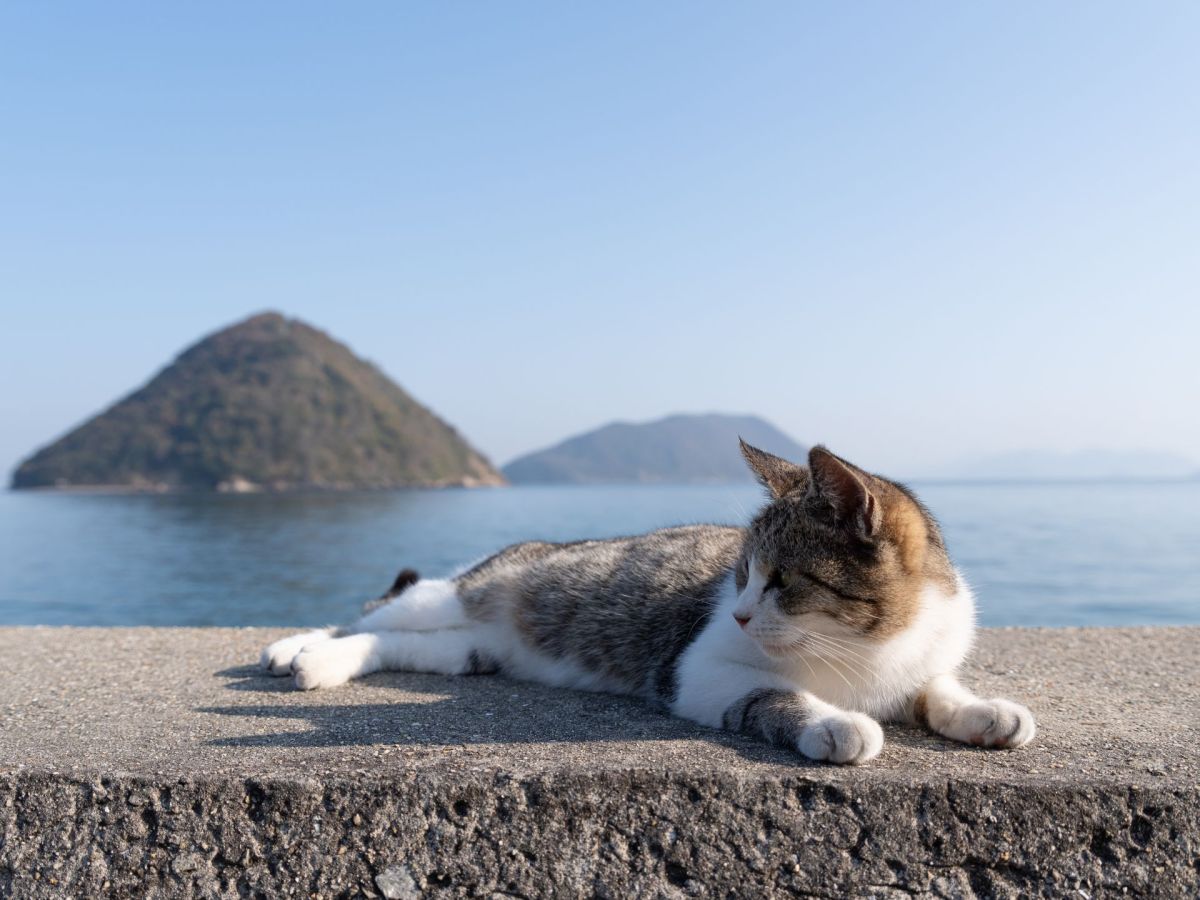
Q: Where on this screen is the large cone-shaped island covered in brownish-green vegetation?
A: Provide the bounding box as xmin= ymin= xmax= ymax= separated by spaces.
xmin=12 ymin=312 xmax=504 ymax=491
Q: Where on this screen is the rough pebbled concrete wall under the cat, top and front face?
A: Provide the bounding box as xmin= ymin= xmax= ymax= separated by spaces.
xmin=0 ymin=628 xmax=1200 ymax=898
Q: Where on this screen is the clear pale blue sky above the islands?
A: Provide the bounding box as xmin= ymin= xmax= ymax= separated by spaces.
xmin=0 ymin=2 xmax=1200 ymax=473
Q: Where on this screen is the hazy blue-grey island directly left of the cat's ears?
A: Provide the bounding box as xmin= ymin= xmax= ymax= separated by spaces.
xmin=503 ymin=414 xmax=808 ymax=485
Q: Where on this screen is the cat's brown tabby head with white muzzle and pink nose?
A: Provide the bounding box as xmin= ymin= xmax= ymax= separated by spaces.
xmin=734 ymin=442 xmax=955 ymax=656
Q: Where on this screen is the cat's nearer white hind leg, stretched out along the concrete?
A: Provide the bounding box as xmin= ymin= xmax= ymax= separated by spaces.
xmin=292 ymin=626 xmax=497 ymax=690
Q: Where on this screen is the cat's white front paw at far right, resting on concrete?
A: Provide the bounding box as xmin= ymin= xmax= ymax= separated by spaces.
xmin=908 ymin=674 xmax=1037 ymax=750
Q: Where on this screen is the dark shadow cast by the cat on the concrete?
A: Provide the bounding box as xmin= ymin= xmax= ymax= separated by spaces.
xmin=198 ymin=666 xmax=970 ymax=766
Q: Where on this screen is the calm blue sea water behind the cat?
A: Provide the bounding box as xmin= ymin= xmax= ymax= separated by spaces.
xmin=0 ymin=482 xmax=1200 ymax=625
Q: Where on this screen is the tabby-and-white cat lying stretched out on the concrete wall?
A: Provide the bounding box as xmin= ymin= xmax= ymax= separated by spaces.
xmin=262 ymin=442 xmax=1036 ymax=763
